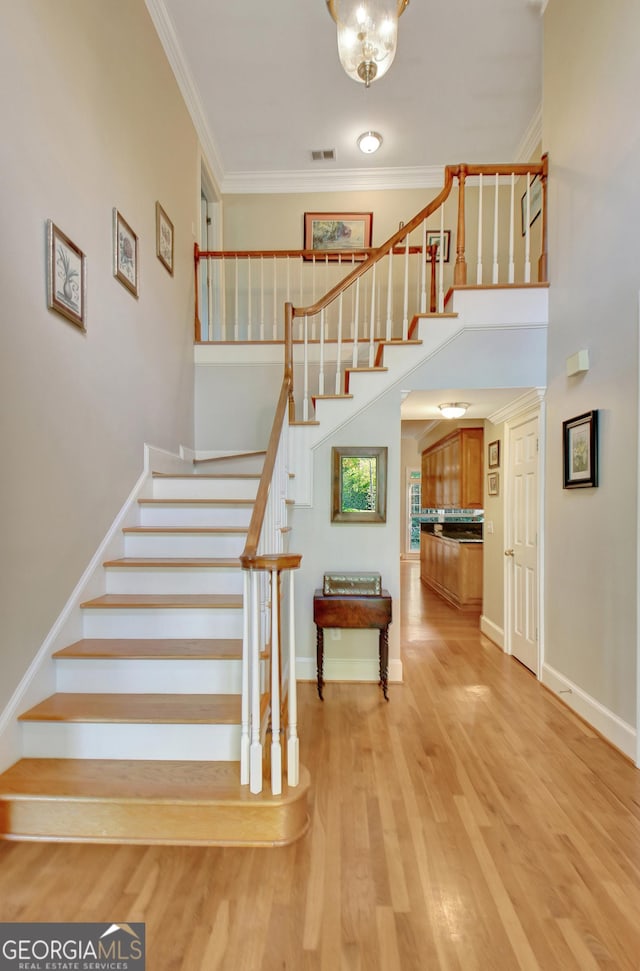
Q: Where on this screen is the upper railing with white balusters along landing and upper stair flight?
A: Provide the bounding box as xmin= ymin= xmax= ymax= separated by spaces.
xmin=195 ymin=156 xmax=547 ymax=420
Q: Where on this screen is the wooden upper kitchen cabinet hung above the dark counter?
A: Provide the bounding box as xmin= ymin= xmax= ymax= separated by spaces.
xmin=422 ymin=428 xmax=484 ymax=509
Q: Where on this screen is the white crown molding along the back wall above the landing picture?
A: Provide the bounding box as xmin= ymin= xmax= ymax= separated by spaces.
xmin=221 ymin=165 xmax=445 ymax=194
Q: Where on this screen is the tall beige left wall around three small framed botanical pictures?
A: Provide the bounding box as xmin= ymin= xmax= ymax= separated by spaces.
xmin=0 ymin=0 xmax=199 ymax=710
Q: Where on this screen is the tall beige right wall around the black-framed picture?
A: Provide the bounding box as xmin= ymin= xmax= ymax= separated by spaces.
xmin=543 ymin=0 xmax=640 ymax=726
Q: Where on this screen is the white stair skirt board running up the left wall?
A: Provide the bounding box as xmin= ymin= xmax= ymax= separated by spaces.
xmin=0 ymin=444 xmax=190 ymax=771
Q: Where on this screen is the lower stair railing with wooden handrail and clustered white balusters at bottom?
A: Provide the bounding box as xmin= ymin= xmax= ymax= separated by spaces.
xmin=240 ymin=316 xmax=302 ymax=795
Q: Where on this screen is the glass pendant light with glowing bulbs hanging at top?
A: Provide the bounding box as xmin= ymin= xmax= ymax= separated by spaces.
xmin=326 ymin=0 xmax=409 ymax=88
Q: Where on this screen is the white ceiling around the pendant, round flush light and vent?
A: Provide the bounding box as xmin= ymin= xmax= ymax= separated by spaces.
xmin=151 ymin=0 xmax=544 ymax=192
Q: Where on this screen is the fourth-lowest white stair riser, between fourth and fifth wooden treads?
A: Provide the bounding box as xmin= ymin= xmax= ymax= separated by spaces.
xmin=106 ymin=567 xmax=243 ymax=594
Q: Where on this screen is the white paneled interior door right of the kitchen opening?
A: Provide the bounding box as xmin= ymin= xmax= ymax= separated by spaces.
xmin=505 ymin=416 xmax=540 ymax=676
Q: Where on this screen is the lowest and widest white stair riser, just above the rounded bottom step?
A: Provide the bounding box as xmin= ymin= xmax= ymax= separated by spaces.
xmin=22 ymin=722 xmax=240 ymax=762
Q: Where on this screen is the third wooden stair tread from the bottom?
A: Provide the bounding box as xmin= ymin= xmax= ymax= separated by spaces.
xmin=53 ymin=637 xmax=242 ymax=661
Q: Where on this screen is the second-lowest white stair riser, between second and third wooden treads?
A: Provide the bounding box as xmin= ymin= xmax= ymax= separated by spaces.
xmin=56 ymin=658 xmax=242 ymax=695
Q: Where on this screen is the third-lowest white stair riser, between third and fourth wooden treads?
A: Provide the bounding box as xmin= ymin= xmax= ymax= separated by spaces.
xmin=83 ymin=607 xmax=242 ymax=637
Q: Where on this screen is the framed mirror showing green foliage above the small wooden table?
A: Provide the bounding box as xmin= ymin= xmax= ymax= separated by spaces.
xmin=331 ymin=446 xmax=387 ymax=523
